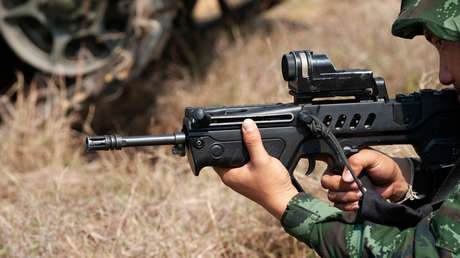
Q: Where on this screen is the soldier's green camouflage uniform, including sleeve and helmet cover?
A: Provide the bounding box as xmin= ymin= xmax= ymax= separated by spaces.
xmin=281 ymin=0 xmax=460 ymax=257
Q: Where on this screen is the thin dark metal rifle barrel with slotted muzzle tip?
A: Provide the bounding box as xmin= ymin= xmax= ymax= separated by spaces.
xmin=86 ymin=133 xmax=186 ymax=151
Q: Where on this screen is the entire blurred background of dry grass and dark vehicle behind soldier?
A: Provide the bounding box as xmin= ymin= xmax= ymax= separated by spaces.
xmin=0 ymin=0 xmax=440 ymax=257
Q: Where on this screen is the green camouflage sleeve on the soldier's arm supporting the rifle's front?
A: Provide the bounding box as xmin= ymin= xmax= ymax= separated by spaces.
xmin=281 ymin=193 xmax=460 ymax=257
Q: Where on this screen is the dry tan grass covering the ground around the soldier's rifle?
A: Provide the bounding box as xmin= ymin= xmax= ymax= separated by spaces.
xmin=0 ymin=0 xmax=437 ymax=257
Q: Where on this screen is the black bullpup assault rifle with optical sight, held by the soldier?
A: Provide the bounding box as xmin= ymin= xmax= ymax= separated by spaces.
xmin=86 ymin=50 xmax=460 ymax=190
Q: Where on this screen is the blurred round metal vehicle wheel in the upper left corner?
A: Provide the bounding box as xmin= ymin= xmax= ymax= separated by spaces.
xmin=0 ymin=0 xmax=133 ymax=76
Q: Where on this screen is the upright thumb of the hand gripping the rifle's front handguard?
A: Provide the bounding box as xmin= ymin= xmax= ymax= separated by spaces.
xmin=242 ymin=119 xmax=269 ymax=163
